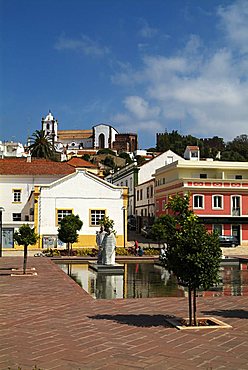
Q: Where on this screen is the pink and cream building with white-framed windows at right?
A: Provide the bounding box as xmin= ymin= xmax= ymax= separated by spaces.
xmin=154 ymin=147 xmax=248 ymax=246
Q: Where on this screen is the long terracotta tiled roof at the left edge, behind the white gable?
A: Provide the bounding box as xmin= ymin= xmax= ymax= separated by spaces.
xmin=0 ymin=158 xmax=75 ymax=175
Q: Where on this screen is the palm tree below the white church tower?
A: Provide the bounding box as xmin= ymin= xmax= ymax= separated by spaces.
xmin=28 ymin=130 xmax=56 ymax=160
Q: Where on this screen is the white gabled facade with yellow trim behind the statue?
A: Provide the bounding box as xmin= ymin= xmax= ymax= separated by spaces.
xmin=38 ymin=170 xmax=124 ymax=247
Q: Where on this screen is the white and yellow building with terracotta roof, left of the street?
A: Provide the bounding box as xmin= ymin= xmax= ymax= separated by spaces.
xmin=0 ymin=158 xmax=126 ymax=249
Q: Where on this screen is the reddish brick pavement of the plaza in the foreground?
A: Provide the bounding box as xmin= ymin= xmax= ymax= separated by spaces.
xmin=0 ymin=257 xmax=248 ymax=370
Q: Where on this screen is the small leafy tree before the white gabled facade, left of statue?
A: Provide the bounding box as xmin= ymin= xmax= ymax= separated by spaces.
xmin=58 ymin=214 xmax=83 ymax=256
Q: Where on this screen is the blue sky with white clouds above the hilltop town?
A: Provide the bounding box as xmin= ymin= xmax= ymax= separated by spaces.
xmin=0 ymin=0 xmax=248 ymax=148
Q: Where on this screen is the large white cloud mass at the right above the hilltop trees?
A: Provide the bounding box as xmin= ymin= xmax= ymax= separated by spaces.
xmin=111 ymin=0 xmax=248 ymax=140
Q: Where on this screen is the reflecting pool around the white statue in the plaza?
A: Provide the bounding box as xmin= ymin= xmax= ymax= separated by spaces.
xmin=58 ymin=262 xmax=248 ymax=299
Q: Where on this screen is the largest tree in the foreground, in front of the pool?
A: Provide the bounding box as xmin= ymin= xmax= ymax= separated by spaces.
xmin=152 ymin=195 xmax=221 ymax=325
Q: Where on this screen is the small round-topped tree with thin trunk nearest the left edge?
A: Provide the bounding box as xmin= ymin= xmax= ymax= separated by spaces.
xmin=14 ymin=225 xmax=38 ymax=275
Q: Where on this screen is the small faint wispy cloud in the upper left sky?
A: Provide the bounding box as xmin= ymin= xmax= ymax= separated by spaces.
xmin=55 ymin=35 xmax=109 ymax=57
